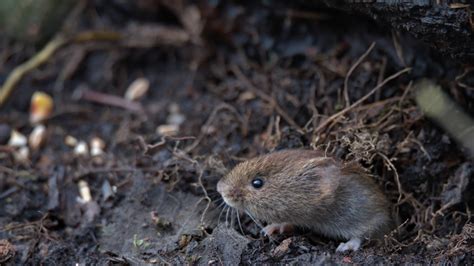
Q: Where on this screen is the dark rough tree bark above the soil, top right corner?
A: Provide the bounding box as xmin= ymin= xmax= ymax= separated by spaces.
xmin=299 ymin=0 xmax=474 ymax=63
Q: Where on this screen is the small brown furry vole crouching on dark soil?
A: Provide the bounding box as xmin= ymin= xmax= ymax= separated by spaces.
xmin=217 ymin=150 xmax=392 ymax=252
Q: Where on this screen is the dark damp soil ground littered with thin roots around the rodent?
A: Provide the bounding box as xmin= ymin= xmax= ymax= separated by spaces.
xmin=0 ymin=0 xmax=474 ymax=265
